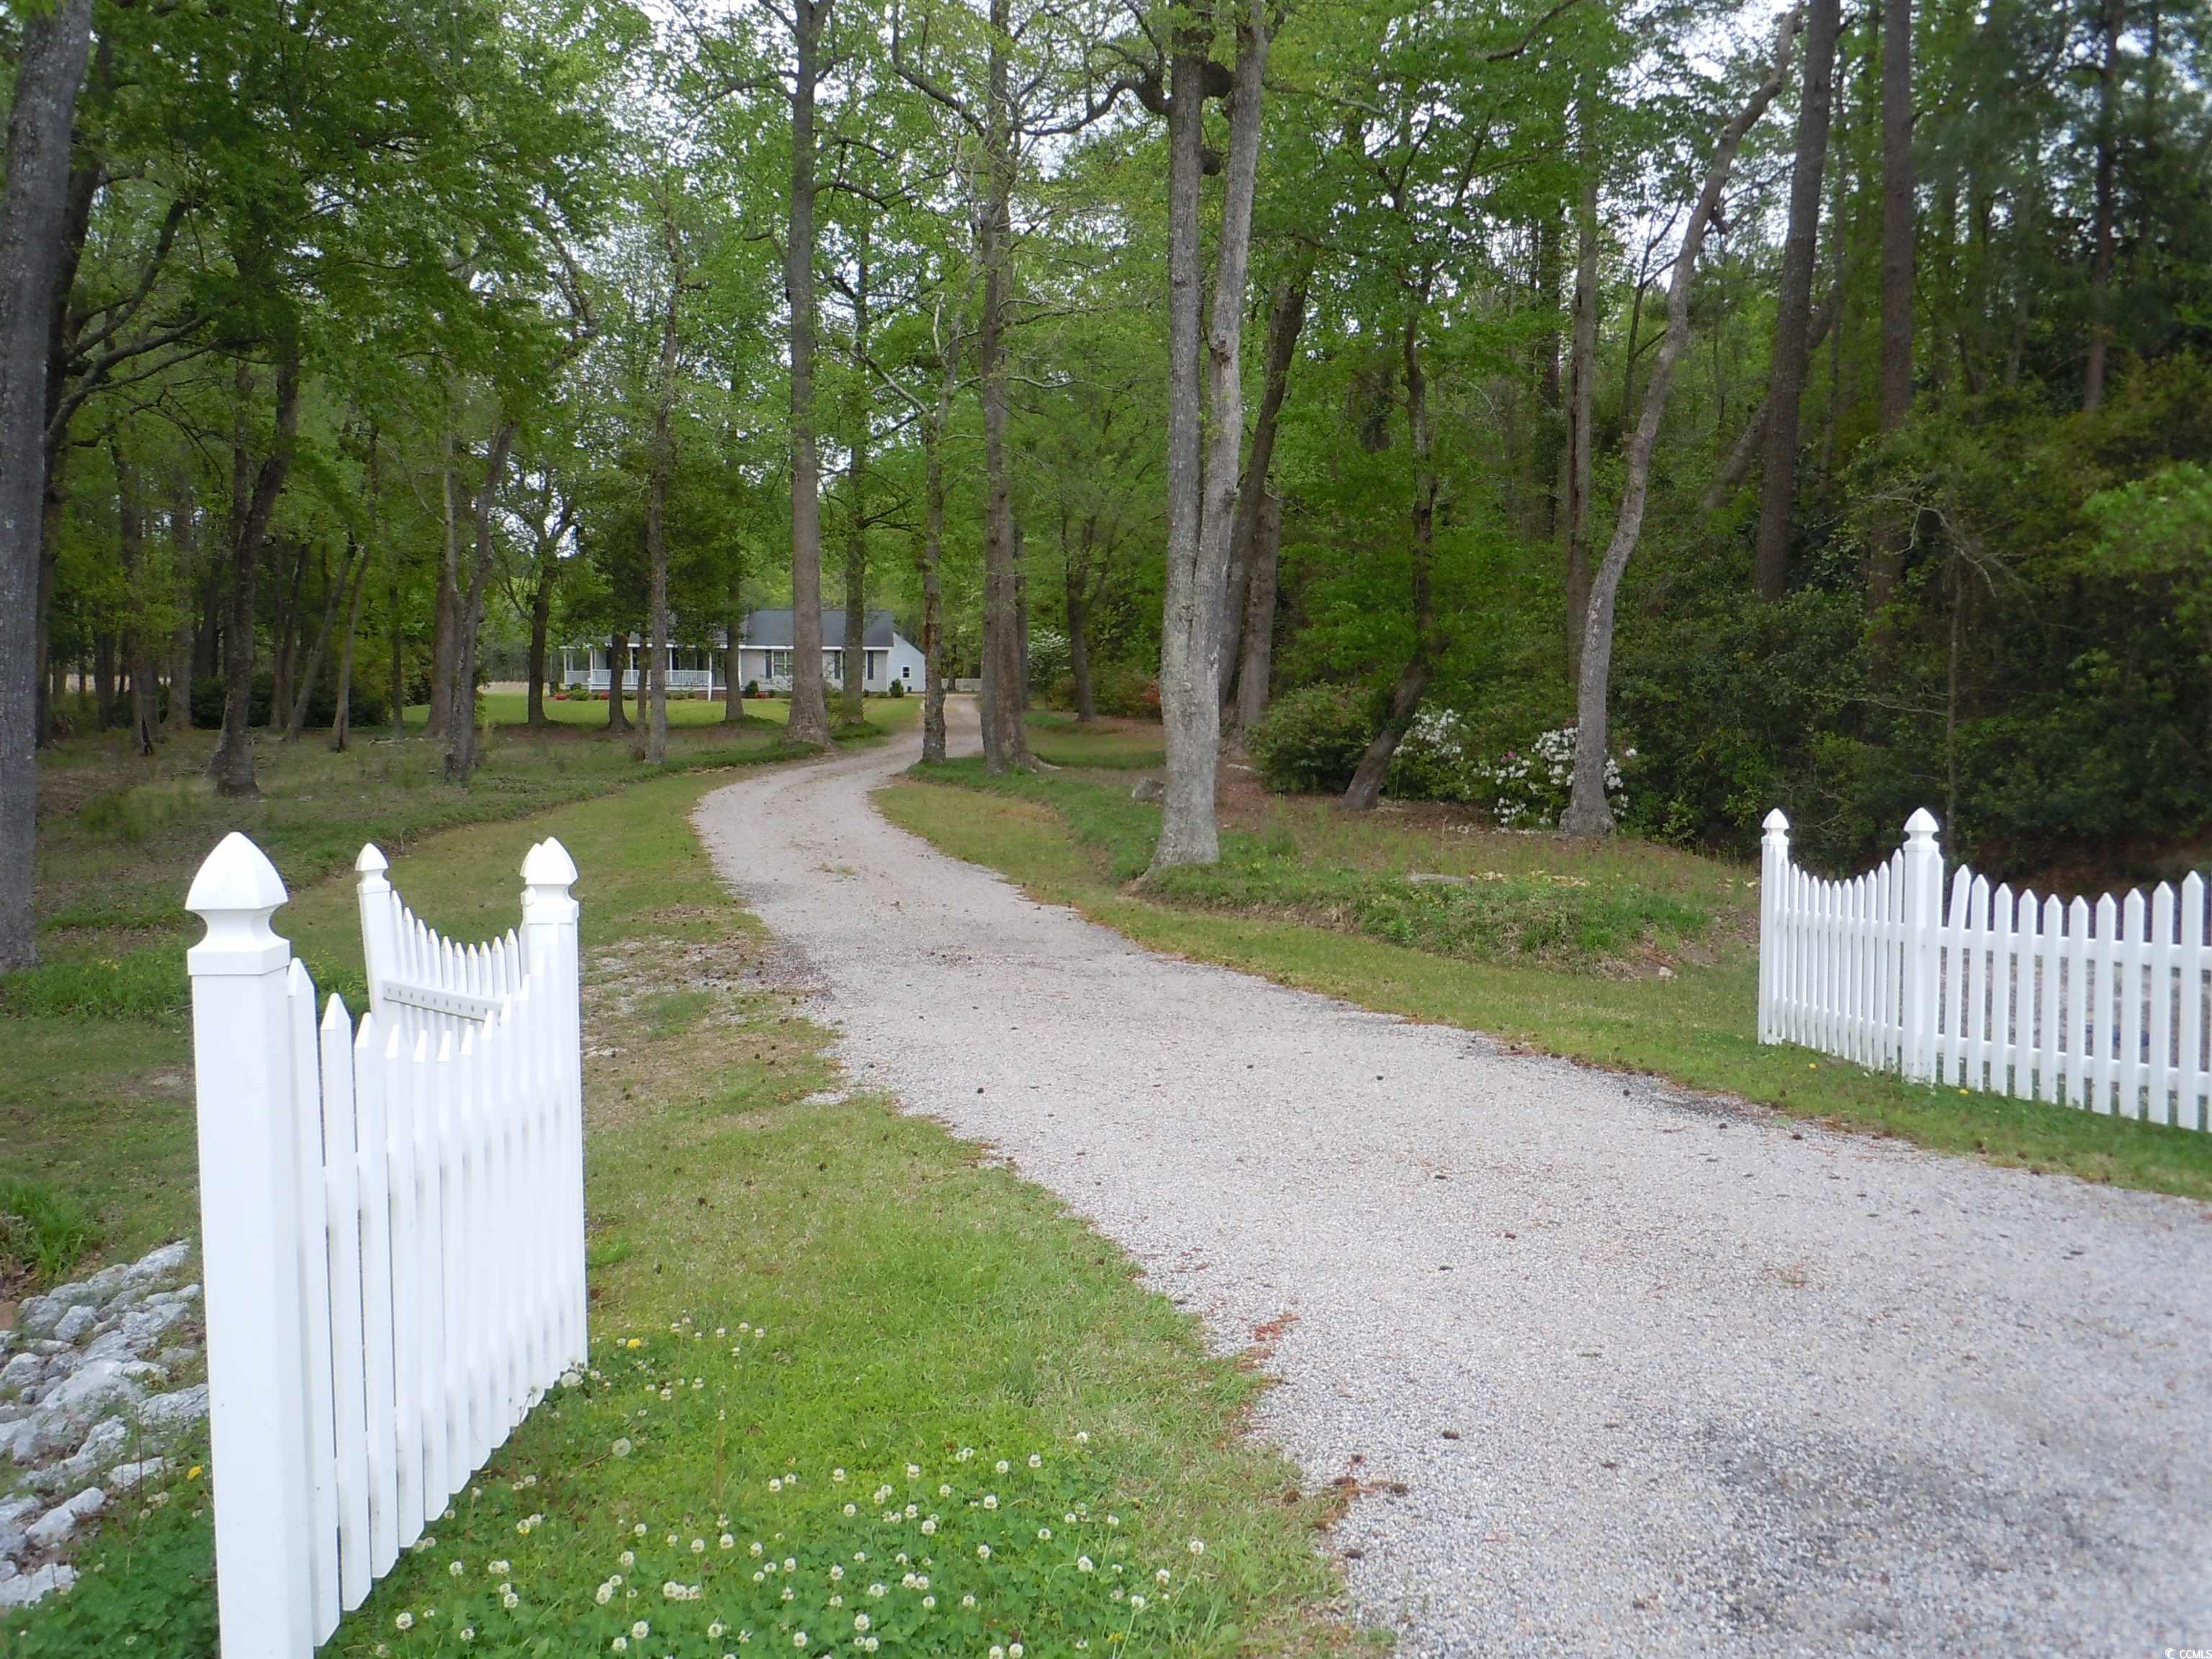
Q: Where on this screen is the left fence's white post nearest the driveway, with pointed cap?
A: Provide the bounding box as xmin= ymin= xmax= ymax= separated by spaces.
xmin=522 ymin=836 xmax=590 ymax=1364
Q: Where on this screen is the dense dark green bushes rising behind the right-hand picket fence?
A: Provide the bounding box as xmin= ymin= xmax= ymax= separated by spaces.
xmin=1617 ymin=361 xmax=2212 ymax=885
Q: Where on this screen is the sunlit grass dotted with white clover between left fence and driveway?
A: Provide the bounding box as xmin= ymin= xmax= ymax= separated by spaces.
xmin=0 ymin=743 xmax=1358 ymax=1659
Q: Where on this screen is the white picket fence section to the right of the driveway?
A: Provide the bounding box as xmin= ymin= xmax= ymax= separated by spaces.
xmin=1758 ymin=811 xmax=2212 ymax=1130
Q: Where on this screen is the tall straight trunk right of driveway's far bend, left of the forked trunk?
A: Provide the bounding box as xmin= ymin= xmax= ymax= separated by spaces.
xmin=976 ymin=0 xmax=1028 ymax=772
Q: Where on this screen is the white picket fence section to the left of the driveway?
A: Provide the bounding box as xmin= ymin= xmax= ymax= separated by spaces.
xmin=186 ymin=834 xmax=586 ymax=1659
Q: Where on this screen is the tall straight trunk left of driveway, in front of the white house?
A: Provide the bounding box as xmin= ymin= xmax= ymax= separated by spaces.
xmin=783 ymin=0 xmax=832 ymax=747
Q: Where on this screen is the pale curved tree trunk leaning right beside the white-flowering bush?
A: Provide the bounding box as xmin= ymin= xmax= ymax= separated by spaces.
xmin=1560 ymin=9 xmax=1805 ymax=836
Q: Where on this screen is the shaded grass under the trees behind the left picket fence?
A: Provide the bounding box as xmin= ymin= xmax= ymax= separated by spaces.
xmin=0 ymin=699 xmax=918 ymax=1296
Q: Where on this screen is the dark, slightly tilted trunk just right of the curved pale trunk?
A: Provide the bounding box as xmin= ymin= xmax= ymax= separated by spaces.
xmin=1752 ymin=0 xmax=1840 ymax=602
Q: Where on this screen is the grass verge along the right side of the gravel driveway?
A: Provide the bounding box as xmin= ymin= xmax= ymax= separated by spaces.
xmin=878 ymin=761 xmax=2212 ymax=1199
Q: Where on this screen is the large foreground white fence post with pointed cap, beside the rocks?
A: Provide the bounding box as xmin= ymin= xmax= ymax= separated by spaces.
xmin=184 ymin=834 xmax=314 ymax=1659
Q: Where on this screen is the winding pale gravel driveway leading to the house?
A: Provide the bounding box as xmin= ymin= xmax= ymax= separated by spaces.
xmin=699 ymin=703 xmax=2212 ymax=1655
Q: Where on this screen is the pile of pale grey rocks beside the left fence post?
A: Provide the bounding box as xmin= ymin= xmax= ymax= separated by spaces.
xmin=0 ymin=1241 xmax=208 ymax=1610
